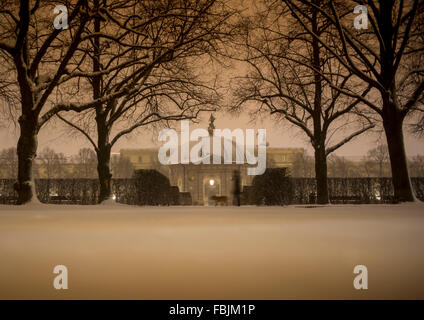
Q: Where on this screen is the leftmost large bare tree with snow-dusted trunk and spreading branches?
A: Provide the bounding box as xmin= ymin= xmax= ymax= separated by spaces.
xmin=0 ymin=0 xmax=171 ymax=204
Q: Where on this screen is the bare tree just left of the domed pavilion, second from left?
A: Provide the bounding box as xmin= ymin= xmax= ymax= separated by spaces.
xmin=58 ymin=0 xmax=231 ymax=202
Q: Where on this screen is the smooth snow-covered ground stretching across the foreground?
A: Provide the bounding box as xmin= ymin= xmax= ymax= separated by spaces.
xmin=0 ymin=204 xmax=424 ymax=299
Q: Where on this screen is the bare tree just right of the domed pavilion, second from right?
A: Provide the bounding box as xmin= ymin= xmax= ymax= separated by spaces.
xmin=233 ymin=1 xmax=374 ymax=204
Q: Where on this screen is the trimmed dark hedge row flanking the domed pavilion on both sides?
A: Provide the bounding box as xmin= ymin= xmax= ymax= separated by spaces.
xmin=0 ymin=175 xmax=424 ymax=205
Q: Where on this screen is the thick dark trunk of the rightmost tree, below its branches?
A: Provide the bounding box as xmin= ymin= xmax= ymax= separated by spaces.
xmin=383 ymin=101 xmax=414 ymax=202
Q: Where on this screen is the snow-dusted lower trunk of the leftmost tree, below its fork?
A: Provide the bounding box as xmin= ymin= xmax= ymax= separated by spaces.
xmin=15 ymin=115 xmax=38 ymax=204
